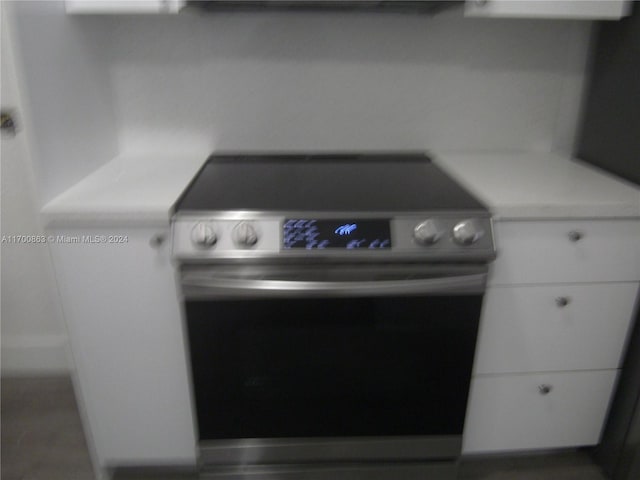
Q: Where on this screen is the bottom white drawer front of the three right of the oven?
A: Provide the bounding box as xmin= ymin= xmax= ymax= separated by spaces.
xmin=463 ymin=370 xmax=618 ymax=453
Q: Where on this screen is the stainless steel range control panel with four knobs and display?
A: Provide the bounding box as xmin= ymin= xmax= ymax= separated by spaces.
xmin=173 ymin=215 xmax=495 ymax=260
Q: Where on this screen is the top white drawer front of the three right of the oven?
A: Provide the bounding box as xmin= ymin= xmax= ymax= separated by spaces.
xmin=489 ymin=220 xmax=640 ymax=285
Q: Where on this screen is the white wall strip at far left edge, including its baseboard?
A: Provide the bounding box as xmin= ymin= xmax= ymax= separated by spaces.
xmin=0 ymin=5 xmax=68 ymax=375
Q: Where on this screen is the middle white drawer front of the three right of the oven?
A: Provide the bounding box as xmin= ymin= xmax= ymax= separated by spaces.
xmin=474 ymin=283 xmax=638 ymax=374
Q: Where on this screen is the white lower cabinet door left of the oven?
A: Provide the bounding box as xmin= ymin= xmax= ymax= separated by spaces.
xmin=49 ymin=229 xmax=195 ymax=468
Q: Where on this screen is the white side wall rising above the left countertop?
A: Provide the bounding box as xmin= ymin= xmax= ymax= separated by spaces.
xmin=9 ymin=0 xmax=117 ymax=206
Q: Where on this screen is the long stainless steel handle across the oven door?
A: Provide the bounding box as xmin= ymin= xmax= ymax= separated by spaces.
xmin=182 ymin=273 xmax=487 ymax=299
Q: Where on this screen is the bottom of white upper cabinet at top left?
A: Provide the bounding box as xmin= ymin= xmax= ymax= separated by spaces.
xmin=65 ymin=0 xmax=185 ymax=14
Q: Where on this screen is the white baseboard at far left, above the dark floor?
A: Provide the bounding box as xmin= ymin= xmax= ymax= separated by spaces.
xmin=0 ymin=334 xmax=70 ymax=376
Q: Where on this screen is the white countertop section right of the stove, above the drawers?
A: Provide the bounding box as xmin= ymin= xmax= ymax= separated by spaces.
xmin=434 ymin=153 xmax=640 ymax=220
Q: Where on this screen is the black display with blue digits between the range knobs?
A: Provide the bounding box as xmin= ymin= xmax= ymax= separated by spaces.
xmin=283 ymin=218 xmax=391 ymax=250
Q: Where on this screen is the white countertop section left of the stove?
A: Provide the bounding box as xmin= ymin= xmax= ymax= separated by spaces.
xmin=41 ymin=153 xmax=208 ymax=227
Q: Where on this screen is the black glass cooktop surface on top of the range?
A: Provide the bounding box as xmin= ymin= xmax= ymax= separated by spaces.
xmin=176 ymin=153 xmax=487 ymax=212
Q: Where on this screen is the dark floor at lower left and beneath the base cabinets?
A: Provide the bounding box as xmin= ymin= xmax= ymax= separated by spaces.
xmin=0 ymin=377 xmax=605 ymax=480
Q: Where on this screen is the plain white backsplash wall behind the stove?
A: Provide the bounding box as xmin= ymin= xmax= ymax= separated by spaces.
xmin=106 ymin=11 xmax=591 ymax=152
